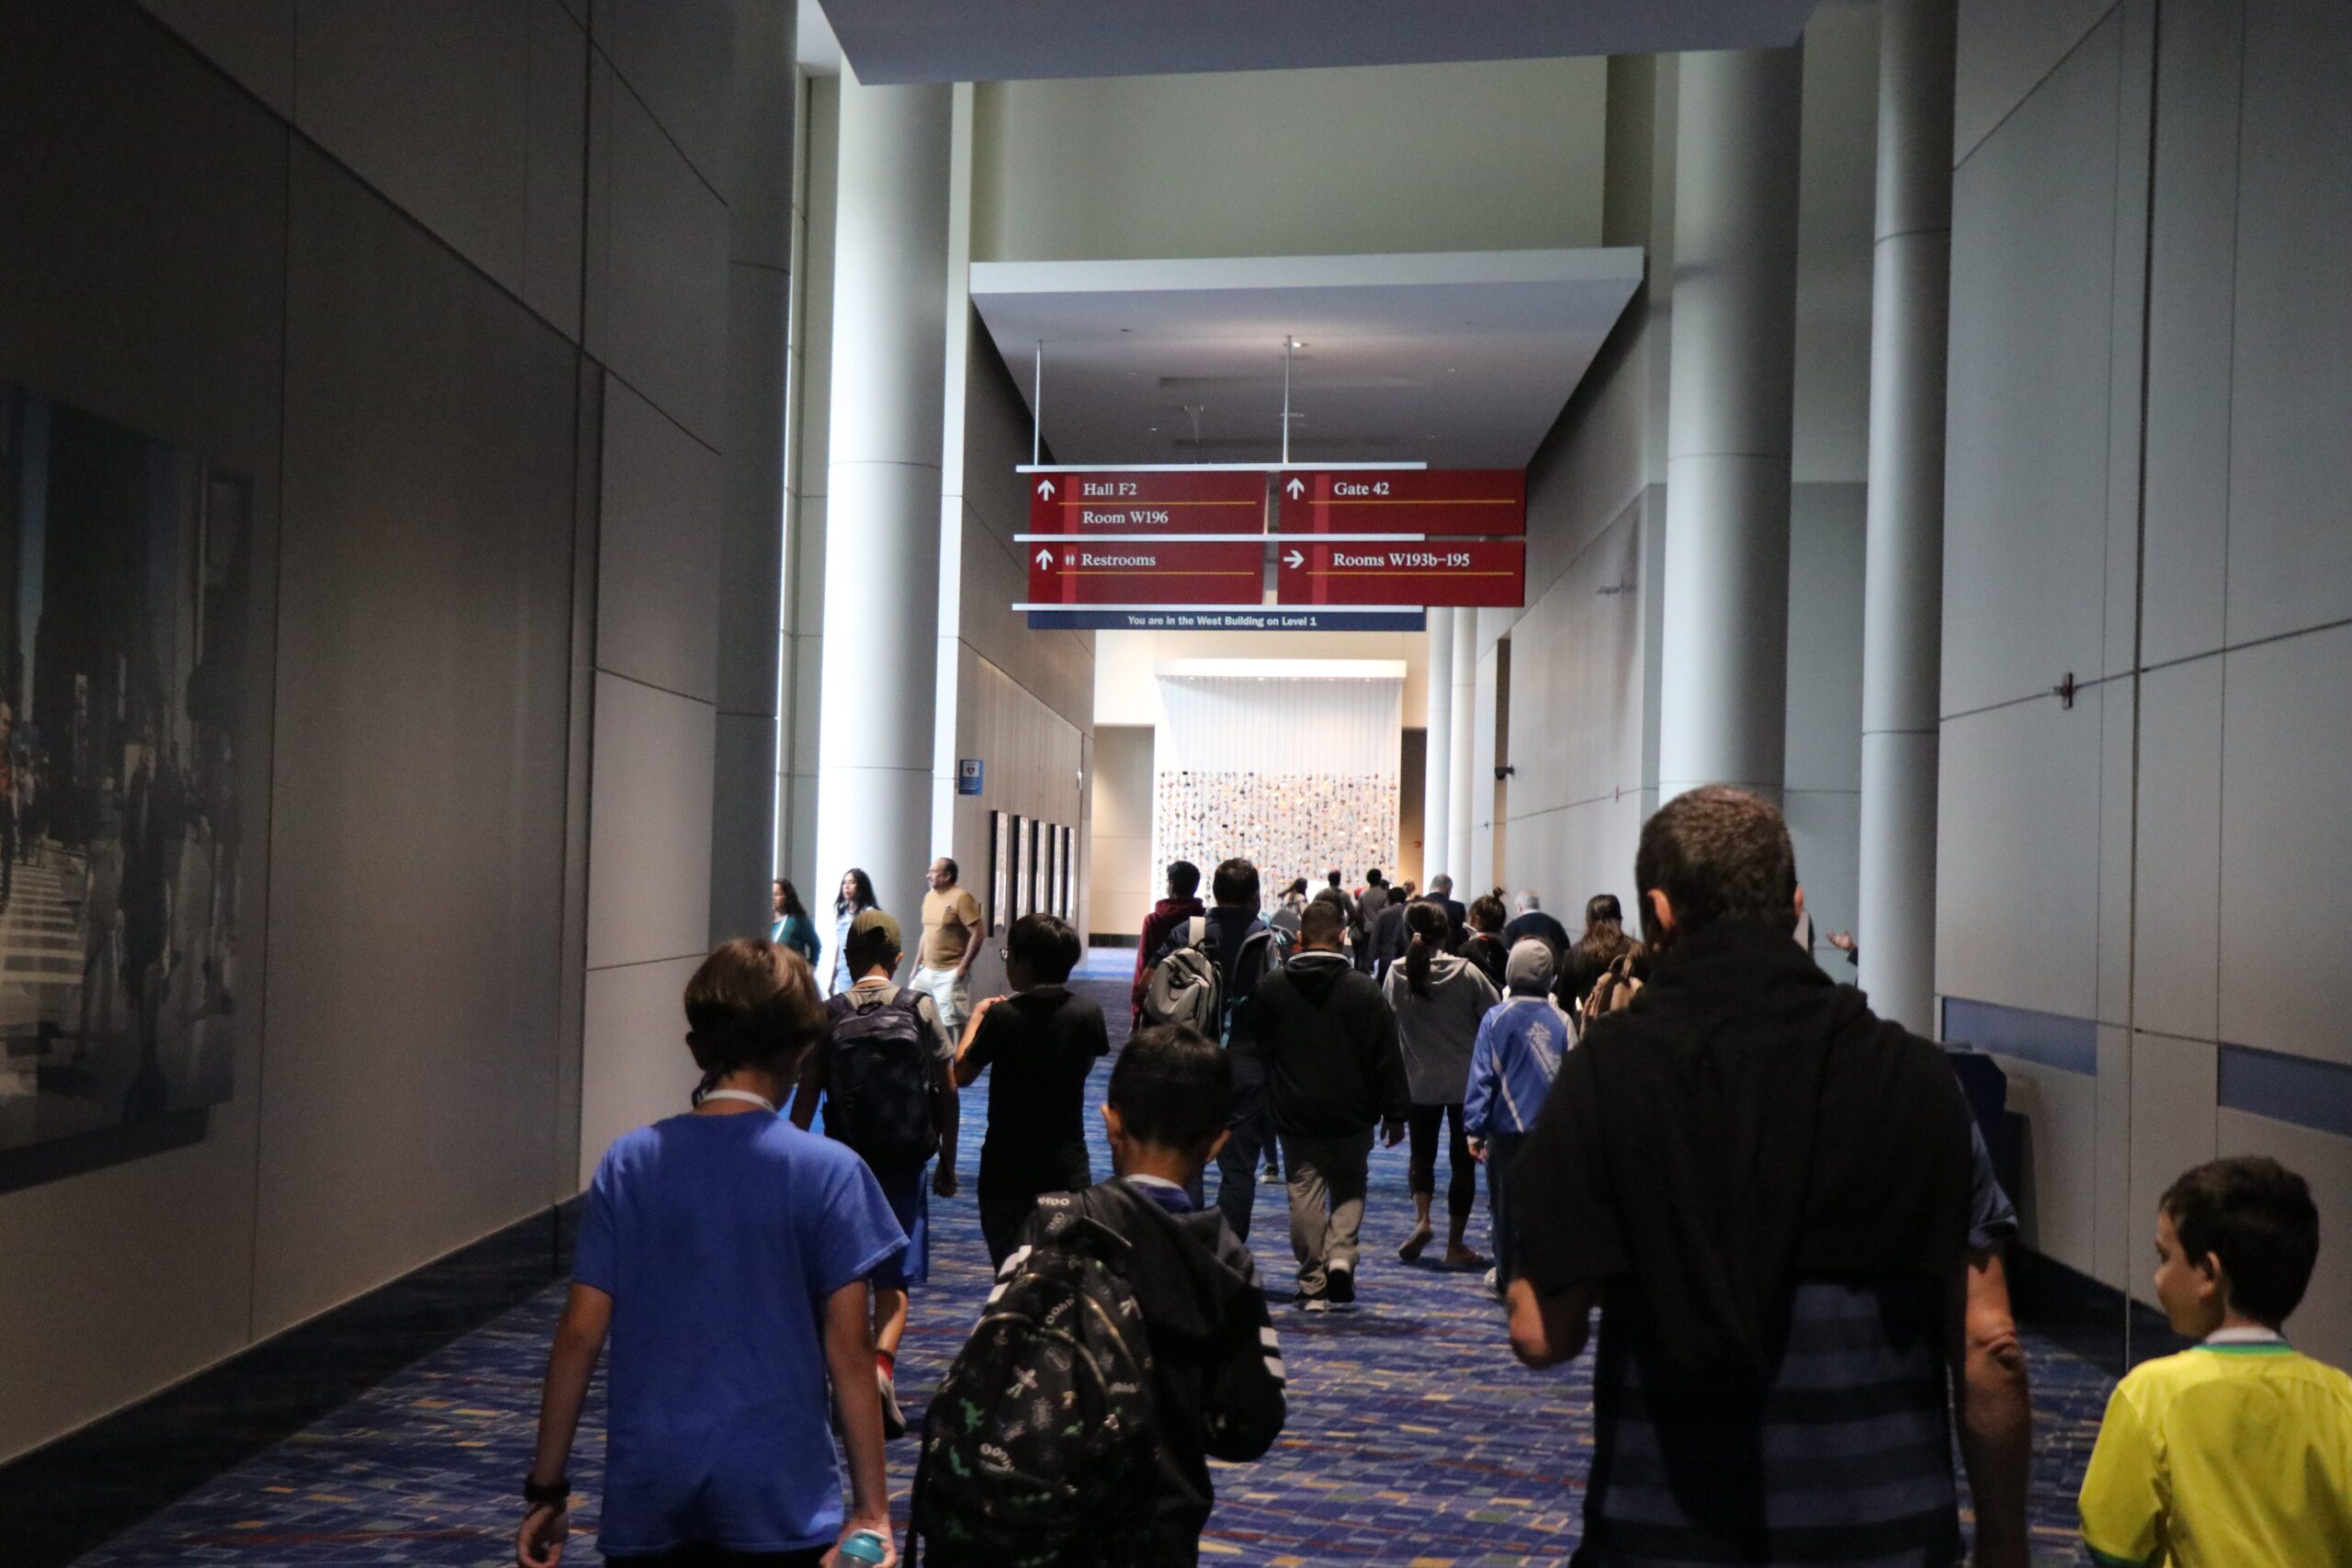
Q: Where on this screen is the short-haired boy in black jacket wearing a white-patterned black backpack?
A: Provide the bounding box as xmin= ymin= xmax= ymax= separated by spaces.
xmin=912 ymin=1027 xmax=1286 ymax=1568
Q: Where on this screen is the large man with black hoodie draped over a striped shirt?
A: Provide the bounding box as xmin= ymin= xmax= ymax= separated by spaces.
xmin=1510 ymin=785 xmax=2030 ymax=1568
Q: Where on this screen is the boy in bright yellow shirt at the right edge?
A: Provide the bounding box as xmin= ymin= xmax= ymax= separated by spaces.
xmin=2082 ymin=1156 xmax=2352 ymax=1568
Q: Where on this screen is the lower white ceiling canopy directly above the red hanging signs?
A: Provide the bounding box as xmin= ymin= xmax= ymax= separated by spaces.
xmin=971 ymin=247 xmax=1642 ymax=468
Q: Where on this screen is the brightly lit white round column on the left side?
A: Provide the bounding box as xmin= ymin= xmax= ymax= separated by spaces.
xmin=814 ymin=66 xmax=955 ymax=924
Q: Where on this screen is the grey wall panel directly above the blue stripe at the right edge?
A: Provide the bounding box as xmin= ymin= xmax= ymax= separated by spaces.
xmin=2221 ymin=626 xmax=2352 ymax=1063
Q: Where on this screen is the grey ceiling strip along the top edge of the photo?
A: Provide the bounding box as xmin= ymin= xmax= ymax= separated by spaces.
xmin=823 ymin=0 xmax=1814 ymax=85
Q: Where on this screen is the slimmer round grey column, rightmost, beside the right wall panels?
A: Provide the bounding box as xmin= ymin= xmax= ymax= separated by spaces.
xmin=1856 ymin=0 xmax=1954 ymax=1034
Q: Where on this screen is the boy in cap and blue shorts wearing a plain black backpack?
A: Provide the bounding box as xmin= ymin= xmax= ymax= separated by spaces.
xmin=793 ymin=909 xmax=957 ymax=1437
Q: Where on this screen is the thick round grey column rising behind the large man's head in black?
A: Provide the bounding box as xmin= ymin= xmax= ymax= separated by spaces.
xmin=1658 ymin=47 xmax=1804 ymax=799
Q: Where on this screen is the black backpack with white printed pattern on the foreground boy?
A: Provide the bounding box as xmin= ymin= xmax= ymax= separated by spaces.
xmin=912 ymin=1194 xmax=1159 ymax=1568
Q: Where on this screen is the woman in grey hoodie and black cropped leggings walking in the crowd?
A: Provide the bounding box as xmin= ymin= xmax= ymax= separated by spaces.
xmin=1383 ymin=903 xmax=1500 ymax=1269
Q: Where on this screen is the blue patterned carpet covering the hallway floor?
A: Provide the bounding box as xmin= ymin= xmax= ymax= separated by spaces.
xmin=83 ymin=973 xmax=2112 ymax=1568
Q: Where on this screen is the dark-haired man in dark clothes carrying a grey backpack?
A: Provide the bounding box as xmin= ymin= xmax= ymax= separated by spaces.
xmin=1143 ymin=861 xmax=1289 ymax=1241
